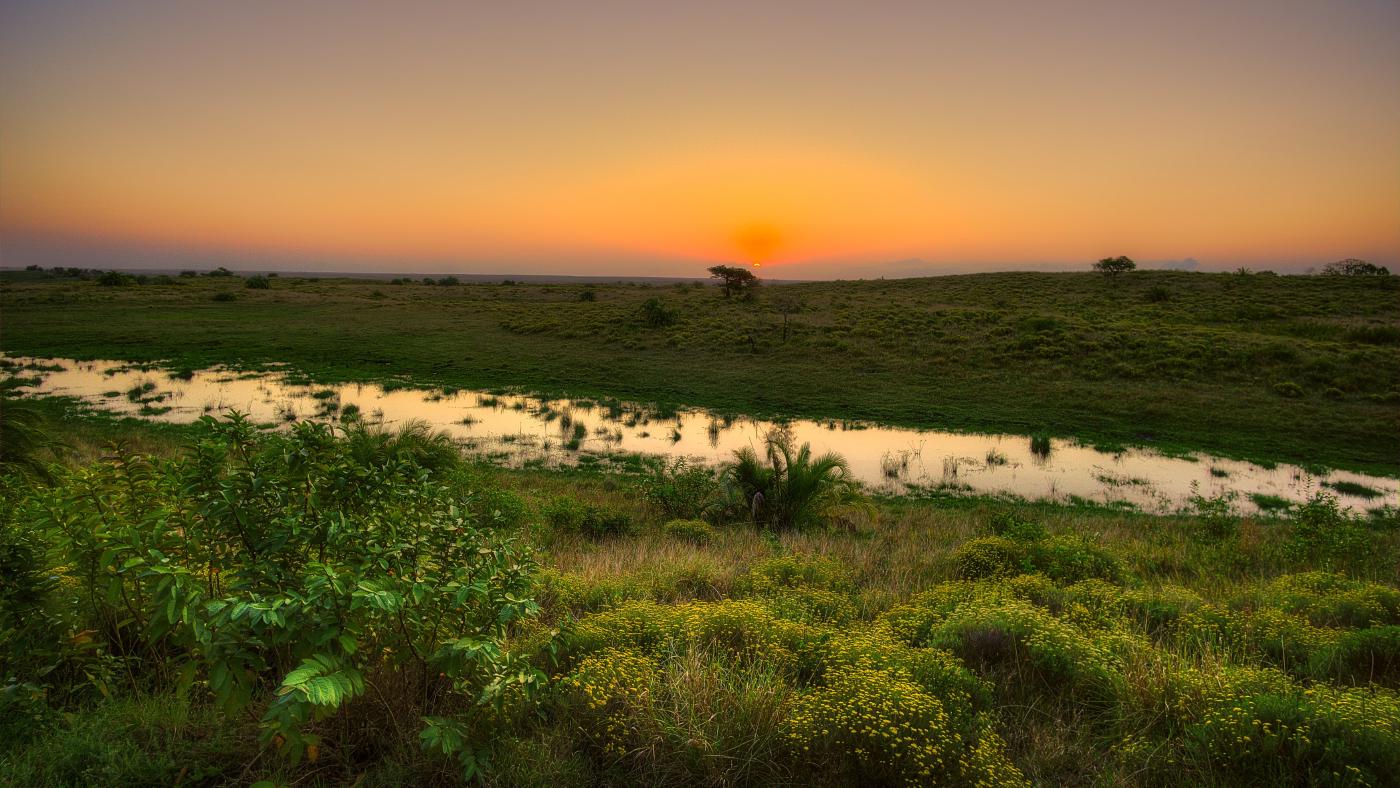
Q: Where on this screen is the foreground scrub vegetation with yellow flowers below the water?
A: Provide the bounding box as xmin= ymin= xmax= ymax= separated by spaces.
xmin=8 ymin=399 xmax=1400 ymax=787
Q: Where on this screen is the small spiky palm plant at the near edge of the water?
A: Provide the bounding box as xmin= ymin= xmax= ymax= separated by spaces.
xmin=724 ymin=432 xmax=861 ymax=529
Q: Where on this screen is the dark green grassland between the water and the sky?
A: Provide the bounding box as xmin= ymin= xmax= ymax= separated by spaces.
xmin=0 ymin=272 xmax=1400 ymax=474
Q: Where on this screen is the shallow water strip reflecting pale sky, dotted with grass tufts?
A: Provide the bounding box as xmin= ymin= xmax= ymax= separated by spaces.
xmin=10 ymin=358 xmax=1400 ymax=512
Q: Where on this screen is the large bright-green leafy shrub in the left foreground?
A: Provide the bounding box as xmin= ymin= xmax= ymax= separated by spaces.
xmin=15 ymin=414 xmax=542 ymax=773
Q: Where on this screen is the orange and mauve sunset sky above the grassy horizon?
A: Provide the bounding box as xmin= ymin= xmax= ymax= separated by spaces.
xmin=0 ymin=0 xmax=1400 ymax=279
